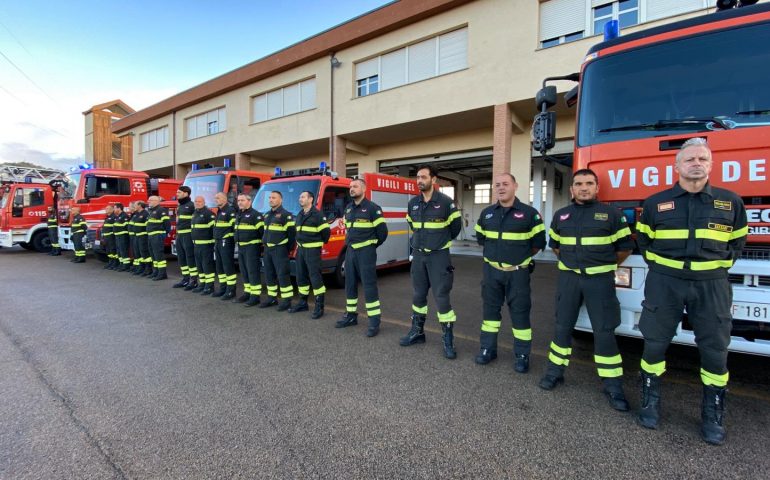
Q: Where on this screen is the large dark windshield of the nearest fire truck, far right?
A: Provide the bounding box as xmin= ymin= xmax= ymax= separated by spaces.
xmin=577 ymin=23 xmax=770 ymax=146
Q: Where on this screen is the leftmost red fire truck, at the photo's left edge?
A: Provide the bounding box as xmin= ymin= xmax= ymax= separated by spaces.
xmin=0 ymin=165 xmax=64 ymax=252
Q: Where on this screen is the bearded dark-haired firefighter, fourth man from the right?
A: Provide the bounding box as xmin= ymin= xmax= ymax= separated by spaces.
xmin=399 ymin=165 xmax=462 ymax=359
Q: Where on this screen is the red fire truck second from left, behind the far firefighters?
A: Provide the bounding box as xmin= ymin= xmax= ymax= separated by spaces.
xmin=59 ymin=164 xmax=182 ymax=250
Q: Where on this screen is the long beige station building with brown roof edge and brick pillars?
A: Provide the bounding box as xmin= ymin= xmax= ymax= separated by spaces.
xmin=113 ymin=0 xmax=713 ymax=238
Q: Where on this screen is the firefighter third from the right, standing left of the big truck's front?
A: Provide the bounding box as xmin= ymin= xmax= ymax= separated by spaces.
xmin=474 ymin=173 xmax=545 ymax=373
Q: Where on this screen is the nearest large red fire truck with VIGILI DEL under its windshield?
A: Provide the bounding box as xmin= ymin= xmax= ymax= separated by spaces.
xmin=533 ymin=2 xmax=770 ymax=355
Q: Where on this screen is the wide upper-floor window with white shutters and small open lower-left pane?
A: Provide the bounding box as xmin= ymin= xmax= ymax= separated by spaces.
xmin=356 ymin=27 xmax=468 ymax=97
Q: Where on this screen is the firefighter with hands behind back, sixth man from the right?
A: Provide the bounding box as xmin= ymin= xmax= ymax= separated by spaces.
xmin=289 ymin=191 xmax=331 ymax=319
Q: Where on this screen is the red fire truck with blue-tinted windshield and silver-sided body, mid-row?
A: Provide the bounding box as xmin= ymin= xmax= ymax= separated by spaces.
xmin=253 ymin=165 xmax=418 ymax=286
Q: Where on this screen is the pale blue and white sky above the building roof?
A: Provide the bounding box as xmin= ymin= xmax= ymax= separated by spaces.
xmin=0 ymin=0 xmax=390 ymax=169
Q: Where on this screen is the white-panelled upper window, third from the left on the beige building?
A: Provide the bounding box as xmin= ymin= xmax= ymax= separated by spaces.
xmin=251 ymin=78 xmax=316 ymax=123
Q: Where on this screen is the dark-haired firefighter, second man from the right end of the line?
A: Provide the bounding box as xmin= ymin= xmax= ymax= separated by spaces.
xmin=540 ymin=169 xmax=633 ymax=412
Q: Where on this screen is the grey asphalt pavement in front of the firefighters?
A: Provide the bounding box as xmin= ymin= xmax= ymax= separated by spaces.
xmin=0 ymin=248 xmax=770 ymax=479
